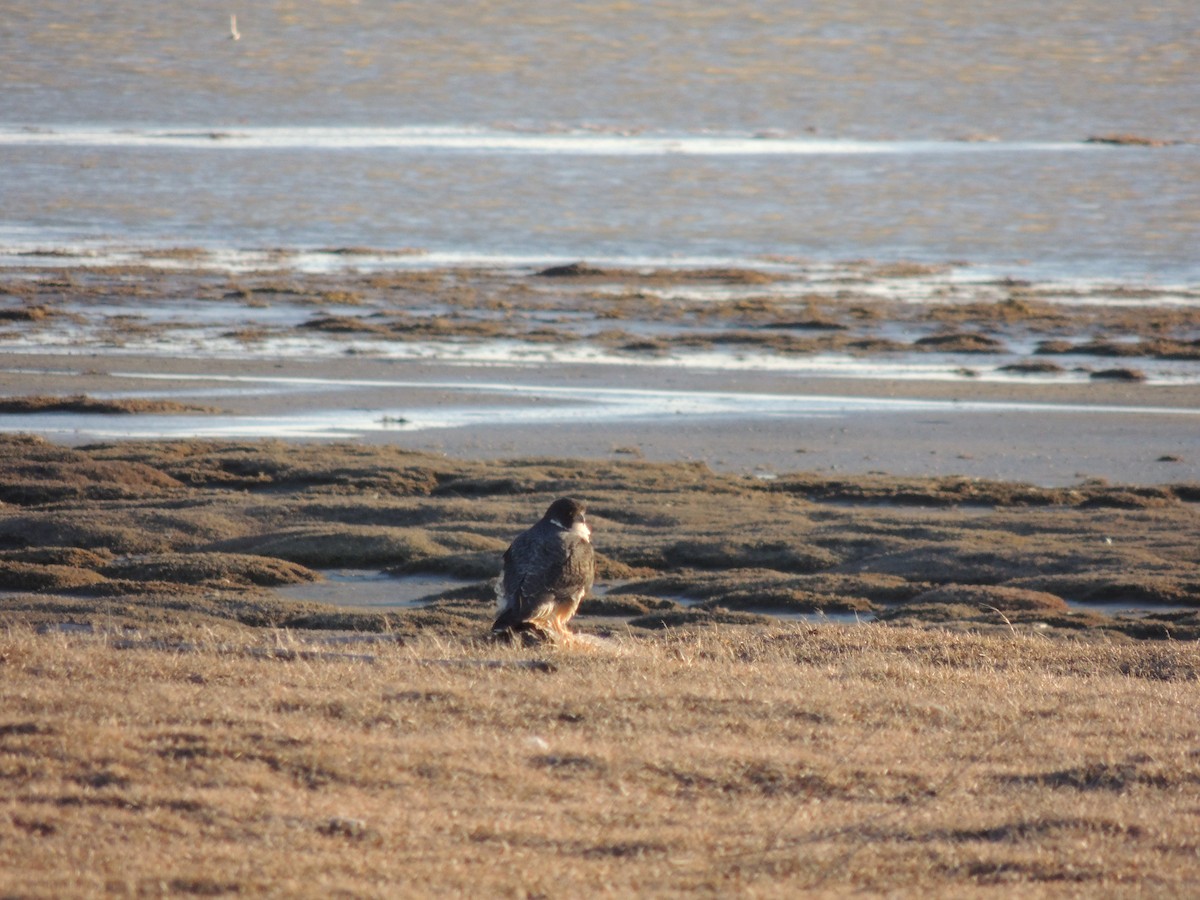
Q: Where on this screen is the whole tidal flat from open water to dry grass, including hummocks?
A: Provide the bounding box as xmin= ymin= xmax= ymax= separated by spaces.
xmin=0 ymin=262 xmax=1200 ymax=637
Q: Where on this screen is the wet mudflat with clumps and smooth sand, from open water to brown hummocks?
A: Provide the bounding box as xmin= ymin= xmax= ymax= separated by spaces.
xmin=0 ymin=260 xmax=1200 ymax=486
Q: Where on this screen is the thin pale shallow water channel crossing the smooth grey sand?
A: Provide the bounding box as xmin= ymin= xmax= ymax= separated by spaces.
xmin=0 ymin=372 xmax=1200 ymax=439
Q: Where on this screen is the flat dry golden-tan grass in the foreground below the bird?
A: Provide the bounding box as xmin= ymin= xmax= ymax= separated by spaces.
xmin=0 ymin=625 xmax=1200 ymax=896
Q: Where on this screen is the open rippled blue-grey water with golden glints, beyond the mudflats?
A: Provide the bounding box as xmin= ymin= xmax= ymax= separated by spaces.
xmin=0 ymin=0 xmax=1200 ymax=281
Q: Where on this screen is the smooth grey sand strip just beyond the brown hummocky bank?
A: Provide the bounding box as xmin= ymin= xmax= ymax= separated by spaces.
xmin=0 ymin=354 xmax=1200 ymax=486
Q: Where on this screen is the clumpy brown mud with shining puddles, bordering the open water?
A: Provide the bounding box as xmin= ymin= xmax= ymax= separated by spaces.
xmin=0 ymin=264 xmax=1200 ymax=380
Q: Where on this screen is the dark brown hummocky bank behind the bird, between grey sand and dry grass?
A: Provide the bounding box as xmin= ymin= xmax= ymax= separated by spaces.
xmin=0 ymin=437 xmax=1200 ymax=640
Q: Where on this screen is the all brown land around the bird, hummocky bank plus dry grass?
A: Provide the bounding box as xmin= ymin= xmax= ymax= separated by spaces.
xmin=0 ymin=437 xmax=1200 ymax=898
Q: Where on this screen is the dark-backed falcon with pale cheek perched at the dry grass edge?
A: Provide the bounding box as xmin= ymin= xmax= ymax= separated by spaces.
xmin=492 ymin=497 xmax=595 ymax=642
